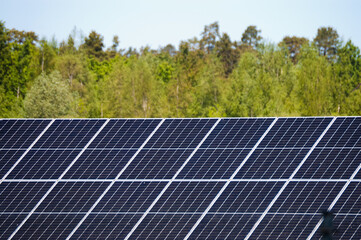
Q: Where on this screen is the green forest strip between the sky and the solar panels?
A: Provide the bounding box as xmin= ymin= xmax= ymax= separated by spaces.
xmin=0 ymin=21 xmax=361 ymax=118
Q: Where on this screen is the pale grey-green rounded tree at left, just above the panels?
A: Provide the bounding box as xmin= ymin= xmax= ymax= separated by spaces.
xmin=24 ymin=71 xmax=74 ymax=118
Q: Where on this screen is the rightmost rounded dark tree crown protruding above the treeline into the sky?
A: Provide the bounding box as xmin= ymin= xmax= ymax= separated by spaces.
xmin=313 ymin=27 xmax=339 ymax=59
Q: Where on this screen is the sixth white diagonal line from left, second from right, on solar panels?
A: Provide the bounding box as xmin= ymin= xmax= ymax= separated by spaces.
xmin=245 ymin=117 xmax=336 ymax=240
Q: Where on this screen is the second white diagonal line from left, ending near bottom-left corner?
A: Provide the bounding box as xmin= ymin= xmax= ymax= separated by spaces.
xmin=9 ymin=119 xmax=109 ymax=240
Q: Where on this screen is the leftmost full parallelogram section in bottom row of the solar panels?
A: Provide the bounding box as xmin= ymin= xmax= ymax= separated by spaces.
xmin=14 ymin=214 xmax=84 ymax=240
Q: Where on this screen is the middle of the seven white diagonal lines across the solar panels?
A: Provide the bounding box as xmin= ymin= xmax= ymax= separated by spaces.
xmin=125 ymin=118 xmax=221 ymax=240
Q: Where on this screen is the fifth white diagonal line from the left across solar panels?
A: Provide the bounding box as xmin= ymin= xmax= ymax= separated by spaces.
xmin=184 ymin=118 xmax=278 ymax=239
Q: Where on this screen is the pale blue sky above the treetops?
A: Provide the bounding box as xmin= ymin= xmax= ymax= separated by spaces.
xmin=0 ymin=0 xmax=361 ymax=49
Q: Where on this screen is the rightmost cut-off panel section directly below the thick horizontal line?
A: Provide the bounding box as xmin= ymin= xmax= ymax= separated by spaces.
xmin=332 ymin=182 xmax=361 ymax=214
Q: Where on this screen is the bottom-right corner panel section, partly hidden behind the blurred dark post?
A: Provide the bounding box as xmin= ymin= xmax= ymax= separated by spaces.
xmin=330 ymin=214 xmax=361 ymax=240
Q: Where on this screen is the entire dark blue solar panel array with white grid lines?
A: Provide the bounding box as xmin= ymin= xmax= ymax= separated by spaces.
xmin=0 ymin=117 xmax=361 ymax=239
